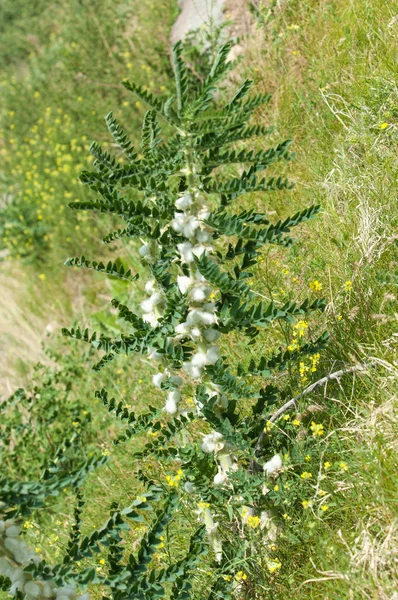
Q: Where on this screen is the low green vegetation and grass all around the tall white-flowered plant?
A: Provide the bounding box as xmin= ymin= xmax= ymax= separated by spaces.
xmin=0 ymin=0 xmax=398 ymax=600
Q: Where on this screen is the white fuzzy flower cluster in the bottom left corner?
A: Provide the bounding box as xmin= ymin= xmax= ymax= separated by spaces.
xmin=0 ymin=519 xmax=89 ymax=600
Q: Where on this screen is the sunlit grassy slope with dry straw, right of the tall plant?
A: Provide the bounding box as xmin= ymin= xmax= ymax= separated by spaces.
xmin=231 ymin=0 xmax=398 ymax=600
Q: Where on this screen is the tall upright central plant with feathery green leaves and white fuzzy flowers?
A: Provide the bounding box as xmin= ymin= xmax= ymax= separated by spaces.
xmin=63 ymin=43 xmax=326 ymax=586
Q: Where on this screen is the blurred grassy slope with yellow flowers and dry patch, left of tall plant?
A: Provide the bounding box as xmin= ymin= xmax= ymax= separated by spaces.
xmin=0 ymin=0 xmax=175 ymax=390
